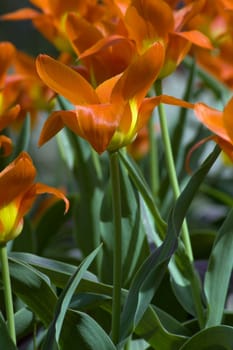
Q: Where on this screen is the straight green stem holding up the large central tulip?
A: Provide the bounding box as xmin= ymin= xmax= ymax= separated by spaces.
xmin=109 ymin=152 xmax=122 ymax=344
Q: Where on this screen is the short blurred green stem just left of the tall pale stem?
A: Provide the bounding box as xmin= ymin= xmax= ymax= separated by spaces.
xmin=148 ymin=117 xmax=159 ymax=201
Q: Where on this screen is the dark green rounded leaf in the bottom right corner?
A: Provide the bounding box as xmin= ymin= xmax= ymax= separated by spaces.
xmin=180 ymin=326 xmax=233 ymax=350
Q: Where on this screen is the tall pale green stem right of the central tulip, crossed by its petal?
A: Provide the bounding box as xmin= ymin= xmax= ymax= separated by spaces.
xmin=156 ymin=80 xmax=193 ymax=261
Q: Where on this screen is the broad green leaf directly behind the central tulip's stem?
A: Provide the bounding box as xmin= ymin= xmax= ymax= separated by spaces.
xmin=101 ymin=164 xmax=149 ymax=288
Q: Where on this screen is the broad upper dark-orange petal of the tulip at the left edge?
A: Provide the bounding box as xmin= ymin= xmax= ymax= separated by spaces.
xmin=0 ymin=152 xmax=36 ymax=208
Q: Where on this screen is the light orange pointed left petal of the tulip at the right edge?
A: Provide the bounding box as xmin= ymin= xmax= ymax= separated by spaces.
xmin=194 ymin=103 xmax=230 ymax=142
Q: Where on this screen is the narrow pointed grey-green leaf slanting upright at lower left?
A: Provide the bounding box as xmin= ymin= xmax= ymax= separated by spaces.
xmin=43 ymin=247 xmax=100 ymax=350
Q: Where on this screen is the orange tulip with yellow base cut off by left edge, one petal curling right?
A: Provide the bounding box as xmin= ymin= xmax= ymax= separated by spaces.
xmin=0 ymin=152 xmax=69 ymax=245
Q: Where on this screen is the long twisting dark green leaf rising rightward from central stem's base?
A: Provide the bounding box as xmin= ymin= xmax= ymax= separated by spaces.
xmin=121 ymin=147 xmax=220 ymax=341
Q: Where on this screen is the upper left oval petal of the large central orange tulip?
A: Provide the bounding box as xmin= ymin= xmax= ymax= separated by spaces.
xmin=36 ymin=55 xmax=99 ymax=105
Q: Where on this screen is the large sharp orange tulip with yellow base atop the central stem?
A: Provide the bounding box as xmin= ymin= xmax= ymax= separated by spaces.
xmin=36 ymin=43 xmax=164 ymax=154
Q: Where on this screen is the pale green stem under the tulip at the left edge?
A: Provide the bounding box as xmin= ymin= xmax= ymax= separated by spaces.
xmin=0 ymin=245 xmax=16 ymax=344
